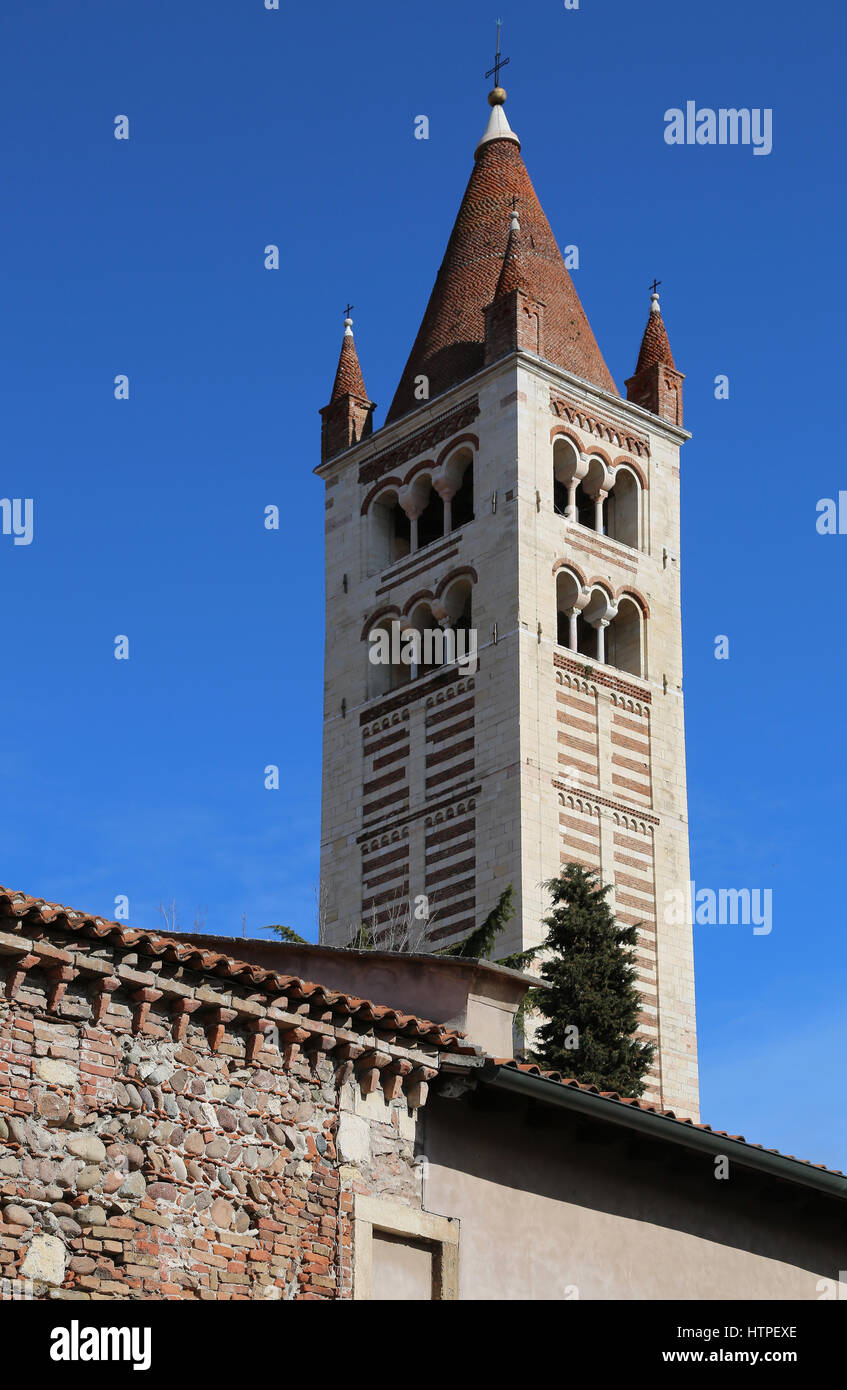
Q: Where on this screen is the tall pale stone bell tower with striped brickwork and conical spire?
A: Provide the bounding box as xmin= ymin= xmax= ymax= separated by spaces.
xmin=316 ymin=86 xmax=698 ymax=1118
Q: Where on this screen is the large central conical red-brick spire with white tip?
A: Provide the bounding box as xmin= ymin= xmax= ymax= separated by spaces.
xmin=388 ymin=88 xmax=619 ymax=421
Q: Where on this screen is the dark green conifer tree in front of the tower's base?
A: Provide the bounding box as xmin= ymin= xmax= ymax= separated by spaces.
xmin=531 ymin=863 xmax=655 ymax=1097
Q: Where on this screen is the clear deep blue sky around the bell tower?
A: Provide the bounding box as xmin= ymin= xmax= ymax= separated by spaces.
xmin=0 ymin=0 xmax=847 ymax=1168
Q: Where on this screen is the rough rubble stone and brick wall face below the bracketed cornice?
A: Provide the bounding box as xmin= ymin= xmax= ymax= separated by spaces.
xmin=0 ymin=960 xmax=420 ymax=1300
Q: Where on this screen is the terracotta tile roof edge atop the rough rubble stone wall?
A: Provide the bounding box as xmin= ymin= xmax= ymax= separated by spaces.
xmin=0 ymin=887 xmax=478 ymax=1056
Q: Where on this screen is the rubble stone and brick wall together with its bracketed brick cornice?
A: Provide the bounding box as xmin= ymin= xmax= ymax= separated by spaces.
xmin=0 ymin=920 xmax=471 ymax=1300
